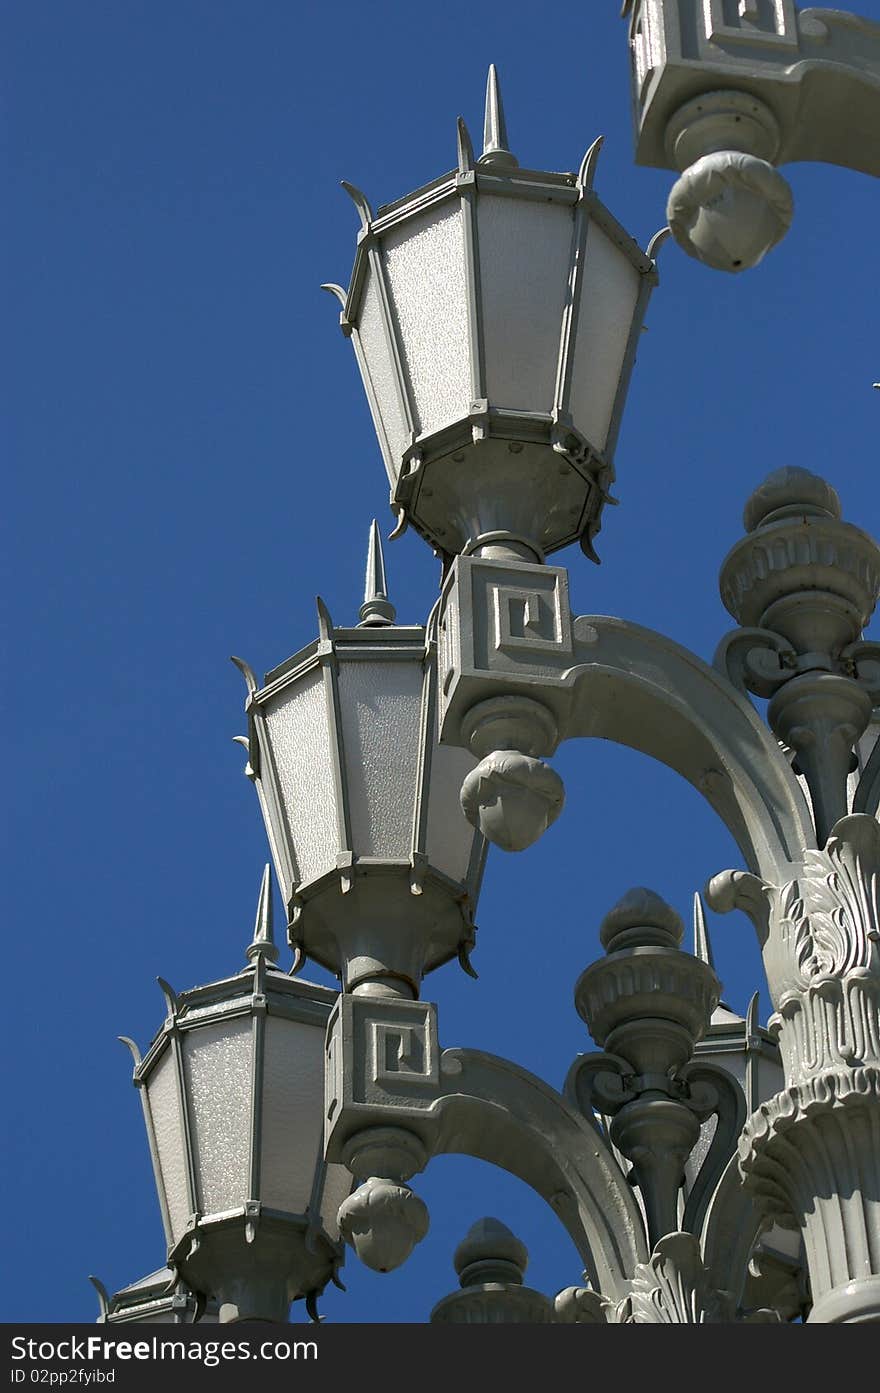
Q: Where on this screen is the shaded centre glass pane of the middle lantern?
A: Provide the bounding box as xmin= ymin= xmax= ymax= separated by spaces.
xmin=340 ymin=660 xmax=422 ymax=858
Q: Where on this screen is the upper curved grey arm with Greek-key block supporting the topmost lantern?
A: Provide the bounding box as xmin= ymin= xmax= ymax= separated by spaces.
xmin=439 ymin=556 xmax=816 ymax=879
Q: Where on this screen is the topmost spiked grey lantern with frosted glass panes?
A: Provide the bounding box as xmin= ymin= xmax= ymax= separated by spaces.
xmin=327 ymin=68 xmax=657 ymax=559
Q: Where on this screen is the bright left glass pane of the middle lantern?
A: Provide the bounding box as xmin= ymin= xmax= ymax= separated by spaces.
xmin=266 ymin=669 xmax=340 ymax=882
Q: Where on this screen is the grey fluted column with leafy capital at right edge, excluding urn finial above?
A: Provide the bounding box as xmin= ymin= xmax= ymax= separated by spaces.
xmin=710 ymin=814 xmax=880 ymax=1322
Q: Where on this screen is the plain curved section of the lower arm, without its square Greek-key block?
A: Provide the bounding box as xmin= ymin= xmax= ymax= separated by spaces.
xmin=432 ymin=1049 xmax=647 ymax=1301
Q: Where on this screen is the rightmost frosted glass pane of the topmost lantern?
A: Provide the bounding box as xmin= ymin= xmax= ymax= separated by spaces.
xmin=571 ymin=223 xmax=641 ymax=450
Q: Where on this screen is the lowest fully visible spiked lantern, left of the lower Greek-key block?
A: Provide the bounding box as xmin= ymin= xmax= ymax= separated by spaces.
xmin=125 ymin=885 xmax=352 ymax=1321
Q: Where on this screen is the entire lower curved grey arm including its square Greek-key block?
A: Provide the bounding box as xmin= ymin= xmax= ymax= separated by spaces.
xmin=324 ymin=992 xmax=647 ymax=1300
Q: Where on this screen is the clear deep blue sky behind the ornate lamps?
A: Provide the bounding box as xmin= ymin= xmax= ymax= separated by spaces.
xmin=6 ymin=0 xmax=880 ymax=1322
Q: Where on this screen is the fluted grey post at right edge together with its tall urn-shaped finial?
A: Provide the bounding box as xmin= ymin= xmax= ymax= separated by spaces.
xmin=710 ymin=469 xmax=880 ymax=1322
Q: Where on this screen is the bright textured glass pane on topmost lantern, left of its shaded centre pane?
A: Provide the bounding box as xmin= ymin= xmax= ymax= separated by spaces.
xmin=383 ymin=203 xmax=471 ymax=433
